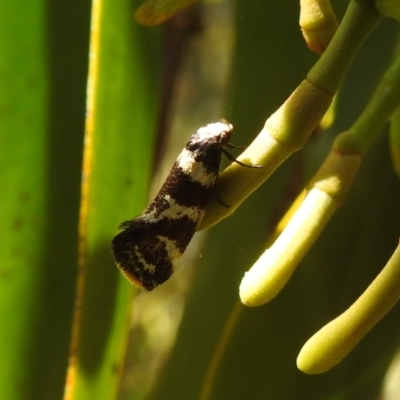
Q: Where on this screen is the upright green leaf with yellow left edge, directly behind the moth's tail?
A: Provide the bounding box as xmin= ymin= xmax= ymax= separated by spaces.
xmin=66 ymin=0 xmax=159 ymax=399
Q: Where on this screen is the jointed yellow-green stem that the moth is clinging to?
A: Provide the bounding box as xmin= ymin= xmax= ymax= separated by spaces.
xmin=199 ymin=1 xmax=380 ymax=230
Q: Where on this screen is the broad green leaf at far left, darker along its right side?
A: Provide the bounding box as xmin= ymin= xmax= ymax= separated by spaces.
xmin=0 ymin=0 xmax=88 ymax=400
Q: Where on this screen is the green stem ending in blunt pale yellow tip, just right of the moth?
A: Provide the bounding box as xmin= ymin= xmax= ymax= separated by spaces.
xmin=240 ymin=48 xmax=400 ymax=306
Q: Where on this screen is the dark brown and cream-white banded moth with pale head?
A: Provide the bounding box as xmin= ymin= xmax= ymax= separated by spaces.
xmin=111 ymin=120 xmax=258 ymax=291
